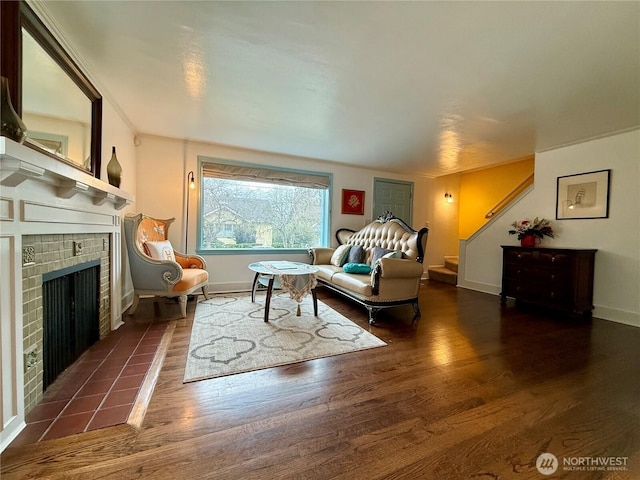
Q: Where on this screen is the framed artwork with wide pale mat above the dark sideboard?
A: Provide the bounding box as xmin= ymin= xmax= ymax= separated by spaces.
xmin=556 ymin=170 xmax=611 ymax=220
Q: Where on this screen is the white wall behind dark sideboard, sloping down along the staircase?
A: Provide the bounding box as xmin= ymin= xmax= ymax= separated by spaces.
xmin=459 ymin=130 xmax=640 ymax=326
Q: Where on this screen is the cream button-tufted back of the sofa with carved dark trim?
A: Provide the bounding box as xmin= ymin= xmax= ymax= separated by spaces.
xmin=336 ymin=218 xmax=429 ymax=263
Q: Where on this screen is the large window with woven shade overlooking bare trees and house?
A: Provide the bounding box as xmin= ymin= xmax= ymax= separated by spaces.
xmin=199 ymin=159 xmax=331 ymax=253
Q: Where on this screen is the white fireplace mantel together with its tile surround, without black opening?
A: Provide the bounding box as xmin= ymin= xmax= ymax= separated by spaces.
xmin=0 ymin=137 xmax=133 ymax=451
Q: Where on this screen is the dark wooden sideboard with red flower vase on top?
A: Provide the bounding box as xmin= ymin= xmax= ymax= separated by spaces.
xmin=500 ymin=245 xmax=597 ymax=316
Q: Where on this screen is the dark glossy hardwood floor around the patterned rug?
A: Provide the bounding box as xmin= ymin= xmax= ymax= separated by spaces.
xmin=1 ymin=282 xmax=640 ymax=480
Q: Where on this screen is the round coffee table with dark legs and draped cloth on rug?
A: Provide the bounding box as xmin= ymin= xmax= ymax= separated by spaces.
xmin=249 ymin=261 xmax=318 ymax=322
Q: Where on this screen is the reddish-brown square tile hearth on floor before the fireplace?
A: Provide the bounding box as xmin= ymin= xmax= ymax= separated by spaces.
xmin=11 ymin=321 xmax=172 ymax=446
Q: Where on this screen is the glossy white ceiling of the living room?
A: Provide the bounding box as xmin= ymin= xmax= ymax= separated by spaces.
xmin=36 ymin=1 xmax=640 ymax=176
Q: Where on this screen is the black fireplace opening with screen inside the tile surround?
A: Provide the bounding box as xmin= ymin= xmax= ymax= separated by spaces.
xmin=42 ymin=260 xmax=100 ymax=391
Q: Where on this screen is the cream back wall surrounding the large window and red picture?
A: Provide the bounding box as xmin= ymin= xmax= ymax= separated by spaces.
xmin=136 ymin=136 xmax=433 ymax=291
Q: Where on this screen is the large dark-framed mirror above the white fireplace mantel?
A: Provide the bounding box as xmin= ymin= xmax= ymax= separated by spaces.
xmin=0 ymin=1 xmax=102 ymax=178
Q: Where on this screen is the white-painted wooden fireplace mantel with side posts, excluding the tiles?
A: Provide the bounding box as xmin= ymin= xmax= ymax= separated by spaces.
xmin=0 ymin=137 xmax=134 ymax=451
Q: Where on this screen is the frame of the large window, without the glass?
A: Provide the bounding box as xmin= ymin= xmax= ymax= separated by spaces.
xmin=196 ymin=155 xmax=333 ymax=255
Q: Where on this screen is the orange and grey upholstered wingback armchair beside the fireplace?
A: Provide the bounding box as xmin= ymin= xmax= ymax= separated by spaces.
xmin=124 ymin=213 xmax=209 ymax=318
